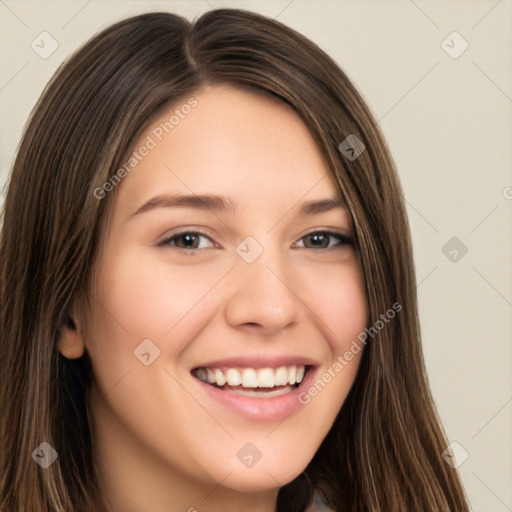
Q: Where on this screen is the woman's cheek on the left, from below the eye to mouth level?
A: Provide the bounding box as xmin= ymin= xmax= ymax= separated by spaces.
xmin=87 ymin=249 xmax=229 ymax=392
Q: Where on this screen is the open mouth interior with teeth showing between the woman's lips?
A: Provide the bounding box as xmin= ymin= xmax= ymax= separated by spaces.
xmin=192 ymin=365 xmax=311 ymax=397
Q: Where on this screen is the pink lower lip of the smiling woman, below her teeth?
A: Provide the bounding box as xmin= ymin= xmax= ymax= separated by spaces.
xmin=193 ymin=368 xmax=316 ymax=422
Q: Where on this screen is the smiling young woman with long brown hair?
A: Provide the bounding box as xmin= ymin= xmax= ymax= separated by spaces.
xmin=0 ymin=9 xmax=468 ymax=512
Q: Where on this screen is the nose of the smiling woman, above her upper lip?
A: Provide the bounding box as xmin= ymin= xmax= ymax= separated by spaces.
xmin=225 ymin=246 xmax=306 ymax=334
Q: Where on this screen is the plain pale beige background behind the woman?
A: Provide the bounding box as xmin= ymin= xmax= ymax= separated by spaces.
xmin=0 ymin=0 xmax=512 ymax=512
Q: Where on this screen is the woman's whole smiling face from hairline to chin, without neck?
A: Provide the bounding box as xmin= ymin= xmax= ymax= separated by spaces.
xmin=77 ymin=85 xmax=367 ymax=492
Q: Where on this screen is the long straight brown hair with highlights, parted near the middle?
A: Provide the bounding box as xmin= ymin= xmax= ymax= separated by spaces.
xmin=0 ymin=9 xmax=469 ymax=512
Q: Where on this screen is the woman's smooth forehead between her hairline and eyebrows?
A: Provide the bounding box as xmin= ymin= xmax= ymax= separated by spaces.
xmin=112 ymin=85 xmax=336 ymax=218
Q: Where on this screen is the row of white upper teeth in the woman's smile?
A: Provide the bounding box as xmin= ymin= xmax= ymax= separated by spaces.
xmin=194 ymin=365 xmax=306 ymax=388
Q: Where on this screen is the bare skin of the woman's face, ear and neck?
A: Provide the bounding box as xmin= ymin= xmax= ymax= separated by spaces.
xmin=60 ymin=85 xmax=367 ymax=512
